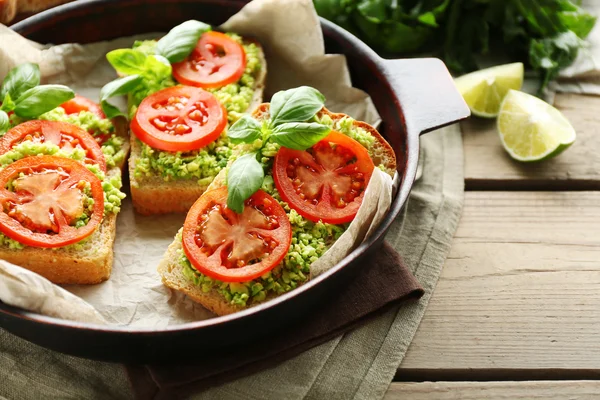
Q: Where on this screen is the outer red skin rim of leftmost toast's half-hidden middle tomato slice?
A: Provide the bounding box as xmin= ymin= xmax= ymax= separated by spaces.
xmin=0 ymin=120 xmax=106 ymax=172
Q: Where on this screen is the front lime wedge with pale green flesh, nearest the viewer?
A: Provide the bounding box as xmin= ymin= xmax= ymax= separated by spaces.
xmin=498 ymin=90 xmax=576 ymax=161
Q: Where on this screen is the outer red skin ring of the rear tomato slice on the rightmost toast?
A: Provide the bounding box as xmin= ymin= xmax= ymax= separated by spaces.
xmin=273 ymin=131 xmax=375 ymax=224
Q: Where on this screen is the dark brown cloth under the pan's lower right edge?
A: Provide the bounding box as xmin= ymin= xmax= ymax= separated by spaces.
xmin=126 ymin=242 xmax=424 ymax=399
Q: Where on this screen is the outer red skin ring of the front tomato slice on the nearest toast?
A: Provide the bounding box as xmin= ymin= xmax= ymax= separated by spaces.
xmin=182 ymin=187 xmax=292 ymax=282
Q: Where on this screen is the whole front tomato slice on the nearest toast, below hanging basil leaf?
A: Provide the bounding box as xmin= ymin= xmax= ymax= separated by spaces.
xmin=183 ymin=187 xmax=292 ymax=282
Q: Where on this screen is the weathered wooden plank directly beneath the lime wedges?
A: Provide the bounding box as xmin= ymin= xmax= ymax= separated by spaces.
xmin=462 ymin=94 xmax=600 ymax=190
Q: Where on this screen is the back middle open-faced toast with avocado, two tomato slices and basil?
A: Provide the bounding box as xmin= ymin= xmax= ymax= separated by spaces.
xmin=102 ymin=20 xmax=266 ymax=214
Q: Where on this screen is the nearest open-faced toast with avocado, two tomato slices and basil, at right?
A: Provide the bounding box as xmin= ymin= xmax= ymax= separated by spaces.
xmin=158 ymin=87 xmax=396 ymax=315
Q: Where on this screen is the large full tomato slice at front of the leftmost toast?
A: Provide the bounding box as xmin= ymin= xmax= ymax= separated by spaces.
xmin=0 ymin=156 xmax=104 ymax=247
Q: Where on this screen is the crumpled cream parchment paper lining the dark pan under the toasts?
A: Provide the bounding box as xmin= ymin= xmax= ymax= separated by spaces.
xmin=0 ymin=0 xmax=392 ymax=328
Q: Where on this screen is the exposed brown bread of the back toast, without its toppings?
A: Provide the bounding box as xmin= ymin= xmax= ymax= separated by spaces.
xmin=129 ymin=41 xmax=267 ymax=215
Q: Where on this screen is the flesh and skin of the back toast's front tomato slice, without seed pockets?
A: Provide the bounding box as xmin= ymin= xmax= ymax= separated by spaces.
xmin=131 ymin=86 xmax=227 ymax=152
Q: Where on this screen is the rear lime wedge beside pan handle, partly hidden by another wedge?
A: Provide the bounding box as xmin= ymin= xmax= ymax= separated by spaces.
xmin=454 ymin=63 xmax=523 ymax=118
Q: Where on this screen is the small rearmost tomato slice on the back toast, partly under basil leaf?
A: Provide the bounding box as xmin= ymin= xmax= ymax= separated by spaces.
xmin=173 ymin=31 xmax=246 ymax=89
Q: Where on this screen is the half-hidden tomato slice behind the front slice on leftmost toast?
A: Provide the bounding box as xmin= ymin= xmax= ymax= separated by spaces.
xmin=0 ymin=120 xmax=106 ymax=172
